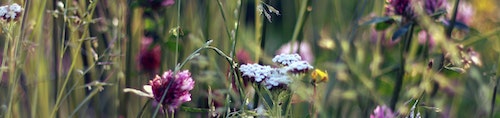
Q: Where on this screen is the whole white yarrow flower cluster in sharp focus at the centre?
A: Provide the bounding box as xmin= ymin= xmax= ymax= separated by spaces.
xmin=239 ymin=54 xmax=313 ymax=89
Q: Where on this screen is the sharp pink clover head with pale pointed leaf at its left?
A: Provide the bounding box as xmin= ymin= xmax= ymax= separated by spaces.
xmin=123 ymin=70 xmax=194 ymax=111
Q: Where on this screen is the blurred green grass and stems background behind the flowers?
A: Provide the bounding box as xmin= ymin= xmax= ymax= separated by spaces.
xmin=0 ymin=0 xmax=500 ymax=117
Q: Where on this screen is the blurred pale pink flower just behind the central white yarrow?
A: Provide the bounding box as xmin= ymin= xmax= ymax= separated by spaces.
xmin=276 ymin=42 xmax=314 ymax=63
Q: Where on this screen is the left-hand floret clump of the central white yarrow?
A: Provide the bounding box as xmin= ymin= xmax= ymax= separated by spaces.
xmin=240 ymin=64 xmax=272 ymax=82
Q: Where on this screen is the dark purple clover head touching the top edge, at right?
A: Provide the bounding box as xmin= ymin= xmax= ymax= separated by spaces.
xmin=386 ymin=0 xmax=413 ymax=17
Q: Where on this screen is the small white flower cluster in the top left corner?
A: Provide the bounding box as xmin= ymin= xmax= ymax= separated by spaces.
xmin=0 ymin=3 xmax=23 ymax=21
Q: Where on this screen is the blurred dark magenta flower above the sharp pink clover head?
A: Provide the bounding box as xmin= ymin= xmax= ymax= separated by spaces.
xmin=137 ymin=37 xmax=161 ymax=72
